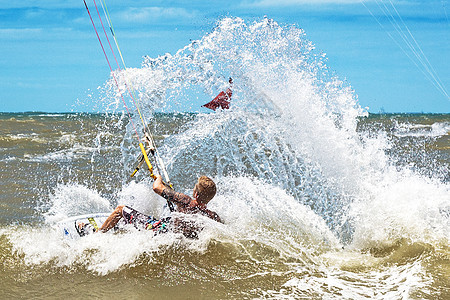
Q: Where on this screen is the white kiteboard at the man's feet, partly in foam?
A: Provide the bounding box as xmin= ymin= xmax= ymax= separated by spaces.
xmin=56 ymin=213 xmax=111 ymax=239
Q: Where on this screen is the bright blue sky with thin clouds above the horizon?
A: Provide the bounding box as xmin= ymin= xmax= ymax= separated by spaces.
xmin=0 ymin=0 xmax=450 ymax=113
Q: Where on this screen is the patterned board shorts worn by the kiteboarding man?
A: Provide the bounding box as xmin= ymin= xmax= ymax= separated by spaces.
xmin=122 ymin=206 xmax=170 ymax=233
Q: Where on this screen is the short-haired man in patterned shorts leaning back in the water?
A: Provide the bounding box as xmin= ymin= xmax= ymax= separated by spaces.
xmin=95 ymin=175 xmax=222 ymax=238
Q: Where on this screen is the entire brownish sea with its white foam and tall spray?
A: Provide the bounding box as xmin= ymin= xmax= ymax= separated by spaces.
xmin=0 ymin=18 xmax=450 ymax=299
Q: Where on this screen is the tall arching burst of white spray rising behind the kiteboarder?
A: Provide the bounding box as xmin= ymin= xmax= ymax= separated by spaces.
xmin=110 ymin=18 xmax=449 ymax=251
